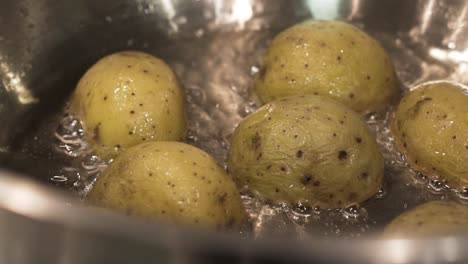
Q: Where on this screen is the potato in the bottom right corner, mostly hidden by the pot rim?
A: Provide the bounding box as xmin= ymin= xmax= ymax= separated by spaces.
xmin=383 ymin=201 xmax=468 ymax=238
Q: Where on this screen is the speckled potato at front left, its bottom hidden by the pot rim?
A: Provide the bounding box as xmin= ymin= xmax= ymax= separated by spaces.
xmin=87 ymin=141 xmax=245 ymax=230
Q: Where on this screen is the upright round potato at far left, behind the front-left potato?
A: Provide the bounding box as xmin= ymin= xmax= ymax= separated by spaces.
xmin=71 ymin=51 xmax=186 ymax=158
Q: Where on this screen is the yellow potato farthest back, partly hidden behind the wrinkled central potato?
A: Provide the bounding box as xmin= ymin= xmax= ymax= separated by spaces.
xmin=255 ymin=21 xmax=398 ymax=113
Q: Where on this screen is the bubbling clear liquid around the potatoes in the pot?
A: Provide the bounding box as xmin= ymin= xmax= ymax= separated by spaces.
xmin=9 ymin=22 xmax=468 ymax=238
